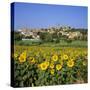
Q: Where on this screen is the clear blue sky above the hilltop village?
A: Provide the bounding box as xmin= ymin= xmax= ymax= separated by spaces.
xmin=14 ymin=3 xmax=88 ymax=30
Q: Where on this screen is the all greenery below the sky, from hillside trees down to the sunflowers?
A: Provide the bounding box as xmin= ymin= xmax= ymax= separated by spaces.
xmin=12 ymin=28 xmax=88 ymax=87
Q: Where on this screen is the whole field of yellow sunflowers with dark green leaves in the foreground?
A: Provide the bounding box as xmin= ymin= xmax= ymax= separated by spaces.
xmin=12 ymin=45 xmax=88 ymax=87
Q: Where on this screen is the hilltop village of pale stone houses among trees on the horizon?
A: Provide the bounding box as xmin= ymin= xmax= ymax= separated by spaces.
xmin=17 ymin=26 xmax=87 ymax=40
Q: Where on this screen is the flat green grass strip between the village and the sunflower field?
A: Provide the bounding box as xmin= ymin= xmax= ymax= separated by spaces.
xmin=15 ymin=40 xmax=88 ymax=47
